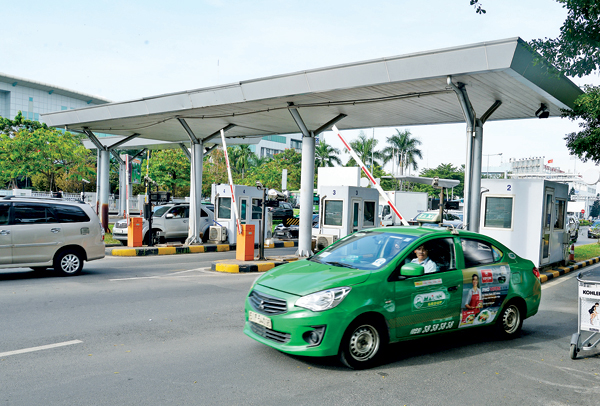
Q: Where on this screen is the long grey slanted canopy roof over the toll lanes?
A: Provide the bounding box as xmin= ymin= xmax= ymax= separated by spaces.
xmin=43 ymin=38 xmax=582 ymax=142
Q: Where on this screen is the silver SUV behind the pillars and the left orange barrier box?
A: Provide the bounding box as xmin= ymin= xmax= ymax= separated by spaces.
xmin=113 ymin=203 xmax=214 ymax=245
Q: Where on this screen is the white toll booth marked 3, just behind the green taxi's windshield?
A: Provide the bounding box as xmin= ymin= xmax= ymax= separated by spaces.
xmin=313 ymin=186 xmax=379 ymax=250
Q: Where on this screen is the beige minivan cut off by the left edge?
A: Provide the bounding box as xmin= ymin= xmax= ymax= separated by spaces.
xmin=0 ymin=196 xmax=105 ymax=276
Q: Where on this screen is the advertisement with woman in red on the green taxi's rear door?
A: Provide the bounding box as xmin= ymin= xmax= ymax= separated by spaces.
xmin=458 ymin=265 xmax=510 ymax=328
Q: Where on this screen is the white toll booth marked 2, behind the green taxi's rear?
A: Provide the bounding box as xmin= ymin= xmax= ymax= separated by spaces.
xmin=479 ymin=179 xmax=569 ymax=268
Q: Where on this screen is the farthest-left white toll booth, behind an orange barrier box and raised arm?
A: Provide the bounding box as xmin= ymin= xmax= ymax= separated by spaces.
xmin=210 ymin=184 xmax=273 ymax=244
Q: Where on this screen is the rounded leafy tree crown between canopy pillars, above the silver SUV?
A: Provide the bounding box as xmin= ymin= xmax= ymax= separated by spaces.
xmin=149 ymin=149 xmax=190 ymax=196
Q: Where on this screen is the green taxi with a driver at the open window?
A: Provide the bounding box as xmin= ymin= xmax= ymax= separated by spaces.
xmin=244 ymin=227 xmax=541 ymax=369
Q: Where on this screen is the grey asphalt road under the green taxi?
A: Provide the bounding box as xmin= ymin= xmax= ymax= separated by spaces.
xmin=0 ymin=248 xmax=600 ymax=406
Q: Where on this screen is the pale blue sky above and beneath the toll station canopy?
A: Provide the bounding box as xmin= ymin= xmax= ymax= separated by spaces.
xmin=0 ymin=0 xmax=600 ymax=181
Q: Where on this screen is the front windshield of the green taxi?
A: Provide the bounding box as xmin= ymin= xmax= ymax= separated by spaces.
xmin=310 ymin=231 xmax=417 ymax=269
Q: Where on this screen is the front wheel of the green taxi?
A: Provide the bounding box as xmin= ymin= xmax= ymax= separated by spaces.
xmin=339 ymin=319 xmax=388 ymax=369
